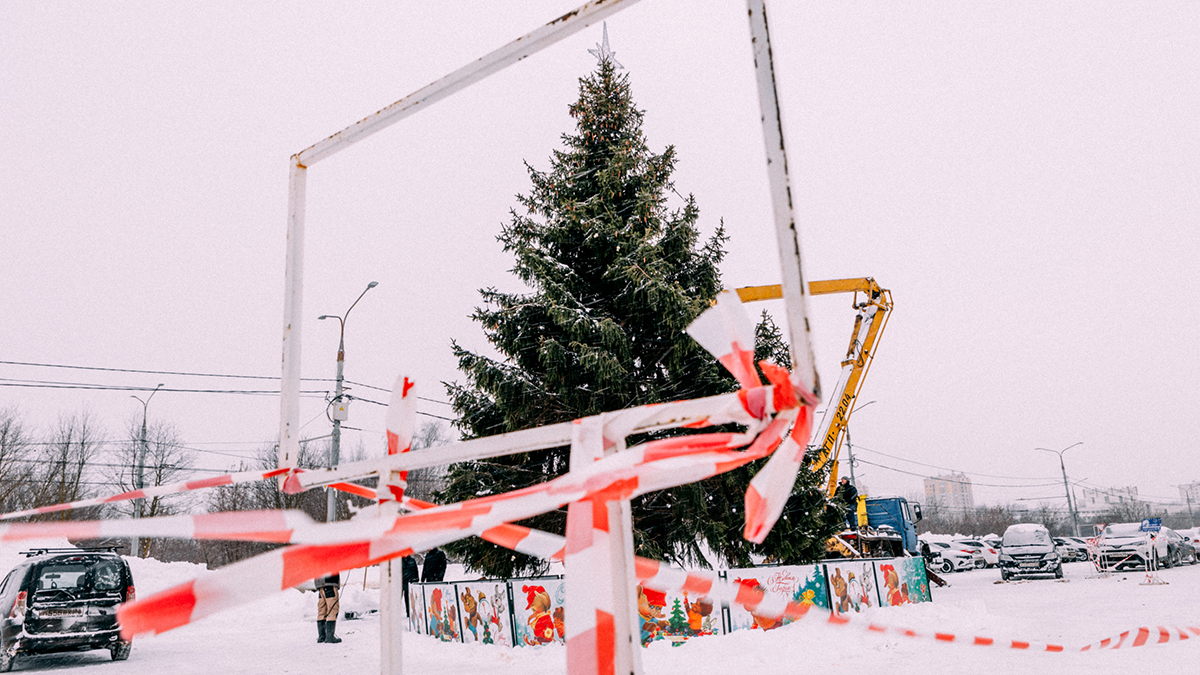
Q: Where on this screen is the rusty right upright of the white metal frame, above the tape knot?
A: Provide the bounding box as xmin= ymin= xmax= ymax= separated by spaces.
xmin=746 ymin=0 xmax=821 ymax=400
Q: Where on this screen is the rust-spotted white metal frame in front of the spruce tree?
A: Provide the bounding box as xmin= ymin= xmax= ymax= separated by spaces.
xmin=280 ymin=0 xmax=820 ymax=674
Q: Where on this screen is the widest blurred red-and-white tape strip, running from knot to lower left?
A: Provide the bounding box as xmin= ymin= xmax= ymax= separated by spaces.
xmin=112 ymin=413 xmax=801 ymax=635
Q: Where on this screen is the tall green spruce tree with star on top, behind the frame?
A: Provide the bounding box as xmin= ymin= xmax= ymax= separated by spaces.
xmin=438 ymin=56 xmax=838 ymax=577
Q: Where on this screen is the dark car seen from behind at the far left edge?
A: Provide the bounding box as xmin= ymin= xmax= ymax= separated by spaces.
xmin=0 ymin=549 xmax=134 ymax=671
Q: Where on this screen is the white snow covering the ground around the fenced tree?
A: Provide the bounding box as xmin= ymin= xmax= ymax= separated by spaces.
xmin=0 ymin=551 xmax=1200 ymax=675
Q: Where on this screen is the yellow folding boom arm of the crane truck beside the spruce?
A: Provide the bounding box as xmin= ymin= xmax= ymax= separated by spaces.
xmin=737 ymin=276 xmax=892 ymax=496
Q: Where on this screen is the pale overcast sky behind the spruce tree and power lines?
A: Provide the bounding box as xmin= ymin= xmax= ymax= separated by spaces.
xmin=0 ymin=0 xmax=1200 ymax=511
